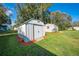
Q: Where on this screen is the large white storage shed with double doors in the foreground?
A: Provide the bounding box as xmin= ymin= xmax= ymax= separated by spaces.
xmin=18 ymin=19 xmax=45 ymax=42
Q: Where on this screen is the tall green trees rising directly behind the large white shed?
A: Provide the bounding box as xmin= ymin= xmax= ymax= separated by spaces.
xmin=16 ymin=3 xmax=52 ymax=23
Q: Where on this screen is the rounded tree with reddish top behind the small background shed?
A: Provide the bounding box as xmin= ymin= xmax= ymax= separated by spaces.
xmin=51 ymin=11 xmax=72 ymax=30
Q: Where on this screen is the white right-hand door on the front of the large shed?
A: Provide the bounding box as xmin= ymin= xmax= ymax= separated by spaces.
xmin=34 ymin=25 xmax=43 ymax=39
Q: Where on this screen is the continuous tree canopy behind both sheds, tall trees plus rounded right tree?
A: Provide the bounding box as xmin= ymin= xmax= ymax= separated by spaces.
xmin=16 ymin=3 xmax=72 ymax=30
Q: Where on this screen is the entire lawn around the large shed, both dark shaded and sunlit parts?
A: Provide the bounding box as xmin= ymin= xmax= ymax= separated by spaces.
xmin=0 ymin=31 xmax=79 ymax=56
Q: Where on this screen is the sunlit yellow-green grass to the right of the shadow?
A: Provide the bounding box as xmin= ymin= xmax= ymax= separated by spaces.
xmin=36 ymin=31 xmax=79 ymax=56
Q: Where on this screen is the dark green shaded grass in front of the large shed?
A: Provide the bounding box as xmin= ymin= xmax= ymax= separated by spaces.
xmin=0 ymin=35 xmax=56 ymax=56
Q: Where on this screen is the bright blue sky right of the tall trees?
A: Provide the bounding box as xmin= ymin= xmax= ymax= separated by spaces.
xmin=48 ymin=3 xmax=79 ymax=22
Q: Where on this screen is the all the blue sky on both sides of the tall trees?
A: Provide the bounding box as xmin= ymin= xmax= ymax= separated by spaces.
xmin=3 ymin=3 xmax=79 ymax=22
